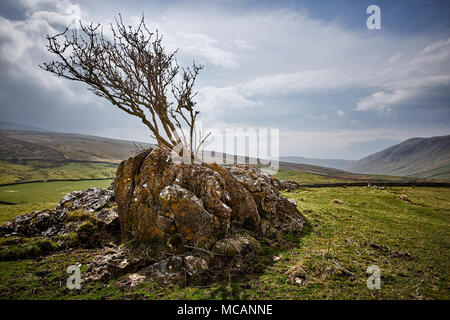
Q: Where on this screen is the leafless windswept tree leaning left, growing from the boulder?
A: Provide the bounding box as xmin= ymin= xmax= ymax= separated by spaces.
xmin=40 ymin=15 xmax=207 ymax=161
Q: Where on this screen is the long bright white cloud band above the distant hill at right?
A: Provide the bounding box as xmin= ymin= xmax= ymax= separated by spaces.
xmin=201 ymin=31 xmax=450 ymax=114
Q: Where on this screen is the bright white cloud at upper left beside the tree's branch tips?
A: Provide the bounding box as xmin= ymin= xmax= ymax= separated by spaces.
xmin=0 ymin=0 xmax=89 ymax=100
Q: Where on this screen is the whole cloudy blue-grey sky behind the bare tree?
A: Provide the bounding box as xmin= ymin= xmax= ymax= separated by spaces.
xmin=0 ymin=0 xmax=450 ymax=159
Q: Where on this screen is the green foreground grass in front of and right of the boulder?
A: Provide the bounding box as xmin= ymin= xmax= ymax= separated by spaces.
xmin=0 ymin=188 xmax=450 ymax=299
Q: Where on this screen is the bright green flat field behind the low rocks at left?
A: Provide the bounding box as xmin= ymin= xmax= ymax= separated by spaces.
xmin=0 ymin=180 xmax=112 ymax=223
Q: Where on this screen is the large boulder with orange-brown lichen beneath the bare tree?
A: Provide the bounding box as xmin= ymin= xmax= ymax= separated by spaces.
xmin=114 ymin=148 xmax=304 ymax=251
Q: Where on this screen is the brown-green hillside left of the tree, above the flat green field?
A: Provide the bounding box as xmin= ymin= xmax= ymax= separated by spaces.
xmin=0 ymin=129 xmax=148 ymax=184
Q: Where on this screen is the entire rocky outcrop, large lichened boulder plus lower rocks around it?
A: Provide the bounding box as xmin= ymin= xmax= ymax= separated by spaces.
xmin=0 ymin=149 xmax=305 ymax=286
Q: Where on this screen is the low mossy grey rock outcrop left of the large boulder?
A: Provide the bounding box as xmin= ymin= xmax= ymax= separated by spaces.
xmin=0 ymin=187 xmax=120 ymax=248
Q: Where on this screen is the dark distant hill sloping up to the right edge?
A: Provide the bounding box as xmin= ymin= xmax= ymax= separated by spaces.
xmin=348 ymin=135 xmax=450 ymax=180
